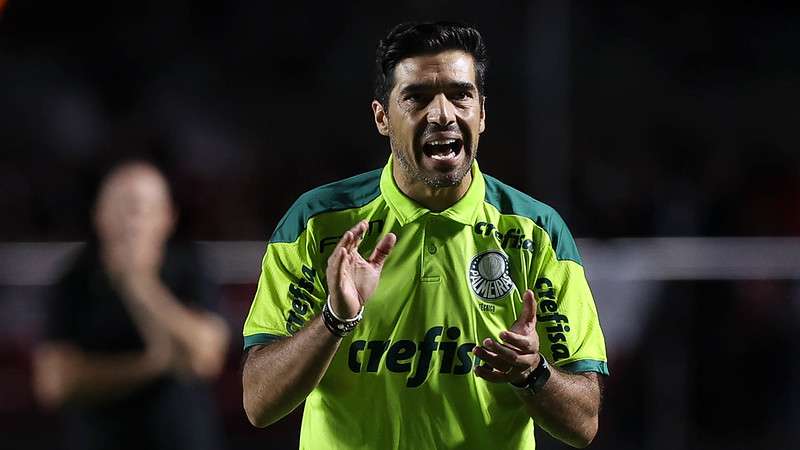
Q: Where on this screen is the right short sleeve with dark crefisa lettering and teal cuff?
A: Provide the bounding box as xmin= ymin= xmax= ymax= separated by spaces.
xmin=532 ymin=222 xmax=608 ymax=375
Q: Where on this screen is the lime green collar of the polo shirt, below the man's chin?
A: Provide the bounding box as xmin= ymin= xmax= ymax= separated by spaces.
xmin=381 ymin=155 xmax=486 ymax=226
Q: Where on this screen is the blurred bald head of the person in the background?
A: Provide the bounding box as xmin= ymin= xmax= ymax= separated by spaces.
xmin=94 ymin=161 xmax=176 ymax=243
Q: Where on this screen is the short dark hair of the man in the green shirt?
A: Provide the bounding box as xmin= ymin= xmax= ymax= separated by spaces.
xmin=375 ymin=22 xmax=489 ymax=106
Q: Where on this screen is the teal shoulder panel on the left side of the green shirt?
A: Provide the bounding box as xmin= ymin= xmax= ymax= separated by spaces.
xmin=269 ymin=169 xmax=383 ymax=243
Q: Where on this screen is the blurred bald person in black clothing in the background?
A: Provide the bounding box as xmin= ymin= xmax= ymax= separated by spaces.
xmin=34 ymin=160 xmax=229 ymax=450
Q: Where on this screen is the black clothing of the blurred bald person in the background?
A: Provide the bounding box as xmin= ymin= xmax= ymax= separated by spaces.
xmin=47 ymin=244 xmax=222 ymax=450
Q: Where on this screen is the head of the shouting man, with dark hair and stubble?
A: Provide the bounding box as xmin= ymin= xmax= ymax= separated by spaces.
xmin=372 ymin=22 xmax=487 ymax=188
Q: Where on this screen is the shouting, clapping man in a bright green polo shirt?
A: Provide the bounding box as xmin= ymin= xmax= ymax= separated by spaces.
xmin=243 ymin=23 xmax=608 ymax=449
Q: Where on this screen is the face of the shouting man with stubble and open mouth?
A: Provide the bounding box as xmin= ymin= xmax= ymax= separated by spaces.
xmin=372 ymin=50 xmax=485 ymax=188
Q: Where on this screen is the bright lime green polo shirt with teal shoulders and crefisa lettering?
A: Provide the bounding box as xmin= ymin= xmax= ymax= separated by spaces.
xmin=244 ymin=158 xmax=608 ymax=450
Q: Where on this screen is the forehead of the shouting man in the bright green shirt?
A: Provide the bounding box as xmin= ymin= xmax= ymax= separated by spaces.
xmin=394 ymin=50 xmax=476 ymax=89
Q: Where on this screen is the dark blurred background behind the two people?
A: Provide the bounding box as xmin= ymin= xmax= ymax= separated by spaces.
xmin=0 ymin=0 xmax=800 ymax=449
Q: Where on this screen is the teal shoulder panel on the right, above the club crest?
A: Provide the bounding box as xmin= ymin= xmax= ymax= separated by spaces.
xmin=483 ymin=174 xmax=583 ymax=265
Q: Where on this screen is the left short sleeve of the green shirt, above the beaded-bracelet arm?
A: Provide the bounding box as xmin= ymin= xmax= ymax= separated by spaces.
xmin=244 ymin=229 xmax=327 ymax=349
